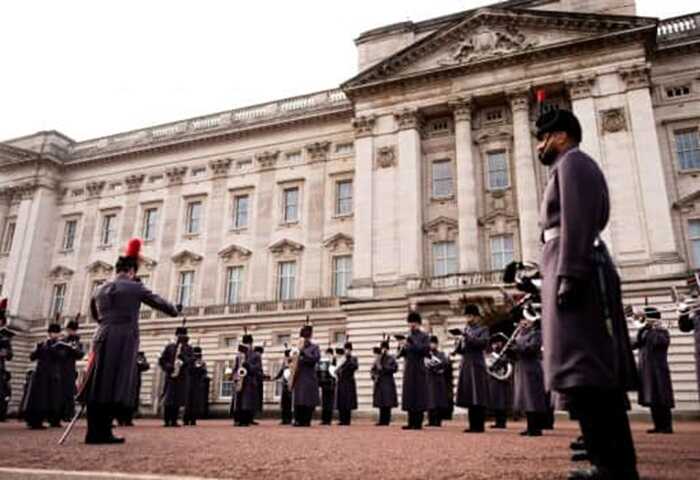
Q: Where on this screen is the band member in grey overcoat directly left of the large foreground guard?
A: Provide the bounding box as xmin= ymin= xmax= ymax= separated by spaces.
xmin=511 ymin=319 xmax=549 ymax=437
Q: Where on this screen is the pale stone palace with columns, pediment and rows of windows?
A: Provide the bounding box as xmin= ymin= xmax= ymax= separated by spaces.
xmin=0 ymin=0 xmax=700 ymax=411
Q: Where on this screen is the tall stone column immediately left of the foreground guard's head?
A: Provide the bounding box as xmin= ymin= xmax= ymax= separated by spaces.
xmin=510 ymin=91 xmax=540 ymax=261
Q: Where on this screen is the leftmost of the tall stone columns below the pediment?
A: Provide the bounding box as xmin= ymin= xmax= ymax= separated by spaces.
xmin=350 ymin=116 xmax=375 ymax=298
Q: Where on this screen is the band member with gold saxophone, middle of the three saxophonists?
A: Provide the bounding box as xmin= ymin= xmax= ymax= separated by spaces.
xmin=231 ymin=333 xmax=262 ymax=427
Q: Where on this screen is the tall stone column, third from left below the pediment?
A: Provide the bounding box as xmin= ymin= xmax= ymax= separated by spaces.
xmin=450 ymin=99 xmax=479 ymax=272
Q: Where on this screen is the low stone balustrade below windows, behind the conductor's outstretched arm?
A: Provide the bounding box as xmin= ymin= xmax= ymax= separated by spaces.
xmin=139 ymin=297 xmax=340 ymax=320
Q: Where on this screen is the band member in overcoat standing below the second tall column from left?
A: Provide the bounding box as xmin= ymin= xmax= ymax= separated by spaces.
xmin=397 ymin=312 xmax=430 ymax=430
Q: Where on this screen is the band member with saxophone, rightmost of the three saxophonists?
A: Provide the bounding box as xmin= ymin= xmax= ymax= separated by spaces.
xmin=292 ymin=325 xmax=321 ymax=427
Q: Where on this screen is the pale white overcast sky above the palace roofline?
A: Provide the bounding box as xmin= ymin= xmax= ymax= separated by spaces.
xmin=0 ymin=0 xmax=700 ymax=140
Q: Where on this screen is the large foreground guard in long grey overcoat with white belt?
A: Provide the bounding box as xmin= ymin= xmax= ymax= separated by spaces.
xmin=536 ymin=109 xmax=638 ymax=479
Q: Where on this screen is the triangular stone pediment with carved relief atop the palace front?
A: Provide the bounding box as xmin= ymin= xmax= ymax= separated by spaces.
xmin=342 ymin=8 xmax=656 ymax=91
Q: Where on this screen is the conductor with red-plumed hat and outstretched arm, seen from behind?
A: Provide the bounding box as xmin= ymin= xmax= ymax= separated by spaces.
xmin=78 ymin=239 xmax=179 ymax=443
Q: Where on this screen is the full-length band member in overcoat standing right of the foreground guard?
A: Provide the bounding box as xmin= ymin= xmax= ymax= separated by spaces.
xmin=632 ymin=307 xmax=675 ymax=433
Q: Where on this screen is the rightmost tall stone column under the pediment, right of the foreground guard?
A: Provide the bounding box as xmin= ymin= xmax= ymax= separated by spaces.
xmin=621 ymin=66 xmax=678 ymax=259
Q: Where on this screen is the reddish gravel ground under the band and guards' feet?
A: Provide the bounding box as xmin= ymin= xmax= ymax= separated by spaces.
xmin=0 ymin=419 xmax=700 ymax=480
